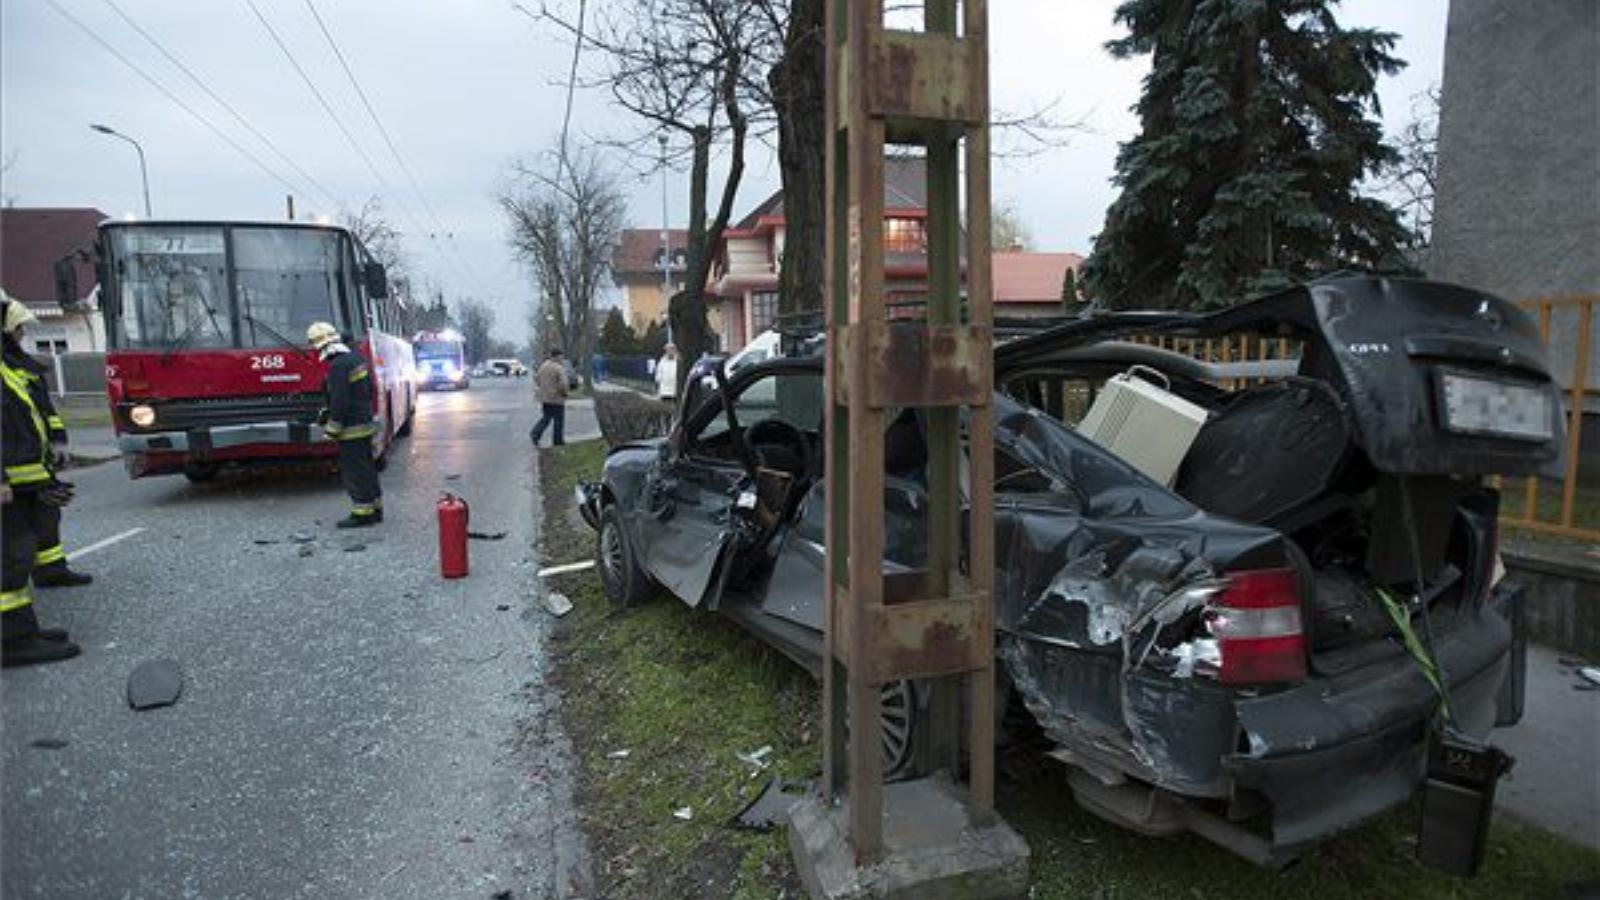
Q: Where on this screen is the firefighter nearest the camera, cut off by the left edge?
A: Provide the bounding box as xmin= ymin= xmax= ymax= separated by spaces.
xmin=0 ymin=299 xmax=80 ymax=668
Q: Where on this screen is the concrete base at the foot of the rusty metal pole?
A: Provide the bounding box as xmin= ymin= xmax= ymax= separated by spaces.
xmin=789 ymin=773 xmax=1029 ymax=900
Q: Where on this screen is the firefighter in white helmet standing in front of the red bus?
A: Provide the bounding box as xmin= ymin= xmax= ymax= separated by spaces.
xmin=306 ymin=322 xmax=384 ymax=528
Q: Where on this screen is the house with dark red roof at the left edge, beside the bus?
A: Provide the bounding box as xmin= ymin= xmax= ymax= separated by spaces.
xmin=0 ymin=207 xmax=107 ymax=354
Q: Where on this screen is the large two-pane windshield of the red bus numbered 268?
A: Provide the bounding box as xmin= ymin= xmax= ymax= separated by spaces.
xmin=107 ymin=226 xmax=354 ymax=351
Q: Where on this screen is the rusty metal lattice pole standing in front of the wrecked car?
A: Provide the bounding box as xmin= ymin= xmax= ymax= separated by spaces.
xmin=822 ymin=0 xmax=995 ymax=865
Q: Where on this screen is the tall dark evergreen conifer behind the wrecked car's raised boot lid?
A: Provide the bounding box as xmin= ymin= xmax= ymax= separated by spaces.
xmin=1083 ymin=0 xmax=1406 ymax=309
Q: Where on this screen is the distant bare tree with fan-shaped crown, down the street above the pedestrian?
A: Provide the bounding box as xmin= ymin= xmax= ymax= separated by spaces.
xmin=499 ymin=151 xmax=624 ymax=383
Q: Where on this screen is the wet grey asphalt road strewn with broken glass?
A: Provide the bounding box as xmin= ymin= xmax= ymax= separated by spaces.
xmin=0 ymin=380 xmax=592 ymax=900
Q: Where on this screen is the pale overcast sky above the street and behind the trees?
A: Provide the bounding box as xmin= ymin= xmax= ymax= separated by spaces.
xmin=0 ymin=0 xmax=1446 ymax=338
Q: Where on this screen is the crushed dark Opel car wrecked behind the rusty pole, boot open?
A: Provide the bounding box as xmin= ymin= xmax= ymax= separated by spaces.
xmin=578 ymin=277 xmax=1562 ymax=865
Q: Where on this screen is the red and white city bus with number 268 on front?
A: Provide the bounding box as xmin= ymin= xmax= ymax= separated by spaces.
xmin=68 ymin=221 xmax=416 ymax=482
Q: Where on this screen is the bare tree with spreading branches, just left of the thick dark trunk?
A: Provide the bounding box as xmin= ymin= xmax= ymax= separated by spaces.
xmin=542 ymin=0 xmax=781 ymax=381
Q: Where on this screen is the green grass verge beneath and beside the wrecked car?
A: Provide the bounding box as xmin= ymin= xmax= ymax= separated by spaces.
xmin=541 ymin=442 xmax=1600 ymax=900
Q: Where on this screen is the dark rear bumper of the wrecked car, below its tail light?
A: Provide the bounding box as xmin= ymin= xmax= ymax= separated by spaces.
xmin=1222 ymin=588 xmax=1523 ymax=849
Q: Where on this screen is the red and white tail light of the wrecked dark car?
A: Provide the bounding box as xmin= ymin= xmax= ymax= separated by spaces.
xmin=1206 ymin=569 xmax=1306 ymax=684
